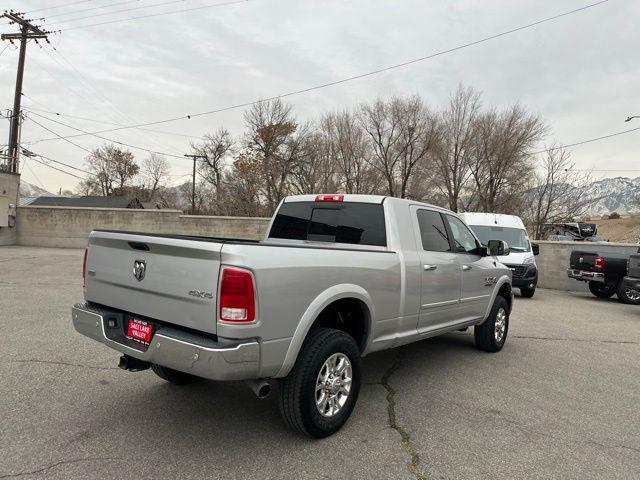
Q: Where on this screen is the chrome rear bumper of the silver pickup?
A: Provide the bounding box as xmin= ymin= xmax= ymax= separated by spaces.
xmin=71 ymin=305 xmax=260 ymax=380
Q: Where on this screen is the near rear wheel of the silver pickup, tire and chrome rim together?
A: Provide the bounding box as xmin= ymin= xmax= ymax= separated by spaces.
xmin=280 ymin=328 xmax=362 ymax=438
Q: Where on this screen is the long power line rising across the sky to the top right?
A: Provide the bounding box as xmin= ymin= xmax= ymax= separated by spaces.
xmin=37 ymin=0 xmax=609 ymax=137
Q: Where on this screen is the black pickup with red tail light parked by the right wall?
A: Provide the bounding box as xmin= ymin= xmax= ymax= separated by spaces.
xmin=567 ymin=249 xmax=640 ymax=305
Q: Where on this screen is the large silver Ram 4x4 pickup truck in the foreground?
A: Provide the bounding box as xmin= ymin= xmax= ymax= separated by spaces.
xmin=72 ymin=195 xmax=513 ymax=437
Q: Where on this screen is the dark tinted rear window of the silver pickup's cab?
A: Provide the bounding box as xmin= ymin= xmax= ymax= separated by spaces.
xmin=269 ymin=202 xmax=387 ymax=247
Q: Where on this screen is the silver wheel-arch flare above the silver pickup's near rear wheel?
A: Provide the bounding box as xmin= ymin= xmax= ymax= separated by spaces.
xmin=275 ymin=283 xmax=375 ymax=378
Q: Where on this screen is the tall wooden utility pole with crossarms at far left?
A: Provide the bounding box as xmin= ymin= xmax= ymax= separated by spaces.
xmin=0 ymin=11 xmax=50 ymax=173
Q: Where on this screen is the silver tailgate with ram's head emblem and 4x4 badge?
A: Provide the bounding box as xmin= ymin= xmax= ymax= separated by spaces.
xmin=85 ymin=231 xmax=223 ymax=333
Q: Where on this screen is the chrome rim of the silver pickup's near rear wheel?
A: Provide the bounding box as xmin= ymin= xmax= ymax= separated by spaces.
xmin=315 ymin=353 xmax=353 ymax=417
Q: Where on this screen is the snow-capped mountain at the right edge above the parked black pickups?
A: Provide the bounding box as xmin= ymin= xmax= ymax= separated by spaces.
xmin=577 ymin=177 xmax=640 ymax=216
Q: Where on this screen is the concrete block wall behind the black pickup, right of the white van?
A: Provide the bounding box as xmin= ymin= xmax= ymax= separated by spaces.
xmin=535 ymin=241 xmax=639 ymax=291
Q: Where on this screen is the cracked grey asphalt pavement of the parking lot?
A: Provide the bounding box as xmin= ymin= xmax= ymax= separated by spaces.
xmin=0 ymin=247 xmax=640 ymax=479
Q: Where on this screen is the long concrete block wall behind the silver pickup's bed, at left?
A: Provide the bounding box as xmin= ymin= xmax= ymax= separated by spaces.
xmin=17 ymin=206 xmax=269 ymax=248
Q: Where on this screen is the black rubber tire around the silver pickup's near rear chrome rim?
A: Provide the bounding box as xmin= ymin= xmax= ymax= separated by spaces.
xmin=279 ymin=328 xmax=362 ymax=438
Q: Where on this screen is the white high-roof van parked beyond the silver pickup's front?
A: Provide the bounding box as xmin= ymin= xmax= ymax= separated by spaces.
xmin=459 ymin=212 xmax=538 ymax=298
